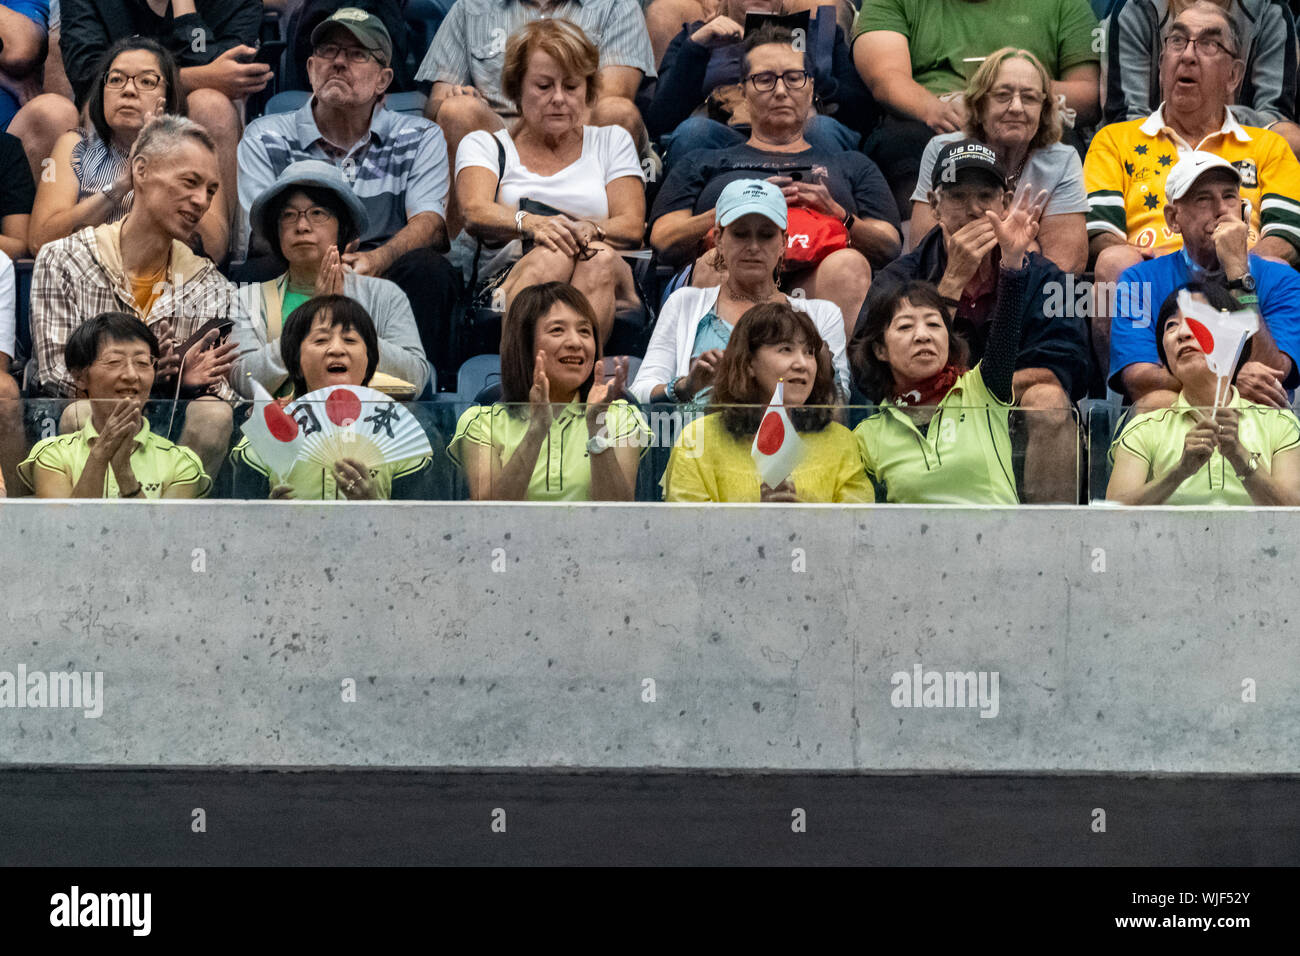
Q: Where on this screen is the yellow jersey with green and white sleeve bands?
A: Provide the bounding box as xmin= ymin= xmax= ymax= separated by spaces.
xmin=1083 ymin=104 xmax=1300 ymax=255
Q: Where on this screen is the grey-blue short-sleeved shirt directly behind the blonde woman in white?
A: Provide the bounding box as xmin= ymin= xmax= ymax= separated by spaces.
xmin=415 ymin=0 xmax=655 ymax=116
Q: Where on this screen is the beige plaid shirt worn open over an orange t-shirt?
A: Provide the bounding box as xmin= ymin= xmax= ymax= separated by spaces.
xmin=31 ymin=224 xmax=241 ymax=399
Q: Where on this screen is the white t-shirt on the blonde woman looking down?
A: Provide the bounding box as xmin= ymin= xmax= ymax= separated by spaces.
xmin=456 ymin=126 xmax=644 ymax=219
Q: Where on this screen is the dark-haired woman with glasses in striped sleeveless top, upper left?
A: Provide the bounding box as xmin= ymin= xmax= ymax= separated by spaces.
xmin=27 ymin=36 xmax=213 ymax=252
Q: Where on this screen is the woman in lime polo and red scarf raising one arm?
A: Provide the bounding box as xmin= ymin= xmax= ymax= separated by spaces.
xmin=853 ymin=194 xmax=1044 ymax=505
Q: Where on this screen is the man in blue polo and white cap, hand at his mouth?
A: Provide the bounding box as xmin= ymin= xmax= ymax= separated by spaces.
xmin=1110 ymin=151 xmax=1300 ymax=411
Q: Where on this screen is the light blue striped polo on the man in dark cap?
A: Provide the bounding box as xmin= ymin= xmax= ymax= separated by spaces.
xmin=239 ymin=98 xmax=450 ymax=255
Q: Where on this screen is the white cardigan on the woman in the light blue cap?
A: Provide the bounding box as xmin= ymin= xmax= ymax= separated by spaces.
xmin=628 ymin=286 xmax=849 ymax=405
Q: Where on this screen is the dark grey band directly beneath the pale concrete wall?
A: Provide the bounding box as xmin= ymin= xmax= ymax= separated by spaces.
xmin=0 ymin=766 xmax=1300 ymax=866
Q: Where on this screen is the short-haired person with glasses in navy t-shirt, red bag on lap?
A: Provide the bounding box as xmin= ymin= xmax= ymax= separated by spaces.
xmin=650 ymin=27 xmax=902 ymax=340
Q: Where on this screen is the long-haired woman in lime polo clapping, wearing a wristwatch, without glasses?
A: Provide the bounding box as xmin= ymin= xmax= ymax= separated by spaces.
xmin=447 ymin=282 xmax=650 ymax=501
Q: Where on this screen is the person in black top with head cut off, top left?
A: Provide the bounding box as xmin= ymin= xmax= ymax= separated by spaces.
xmin=55 ymin=0 xmax=272 ymax=263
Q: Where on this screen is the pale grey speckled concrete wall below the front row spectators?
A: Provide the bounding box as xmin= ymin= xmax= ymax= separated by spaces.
xmin=0 ymin=501 xmax=1300 ymax=773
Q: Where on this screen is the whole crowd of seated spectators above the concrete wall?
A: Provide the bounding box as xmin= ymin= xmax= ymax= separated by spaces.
xmin=0 ymin=0 xmax=1300 ymax=505
